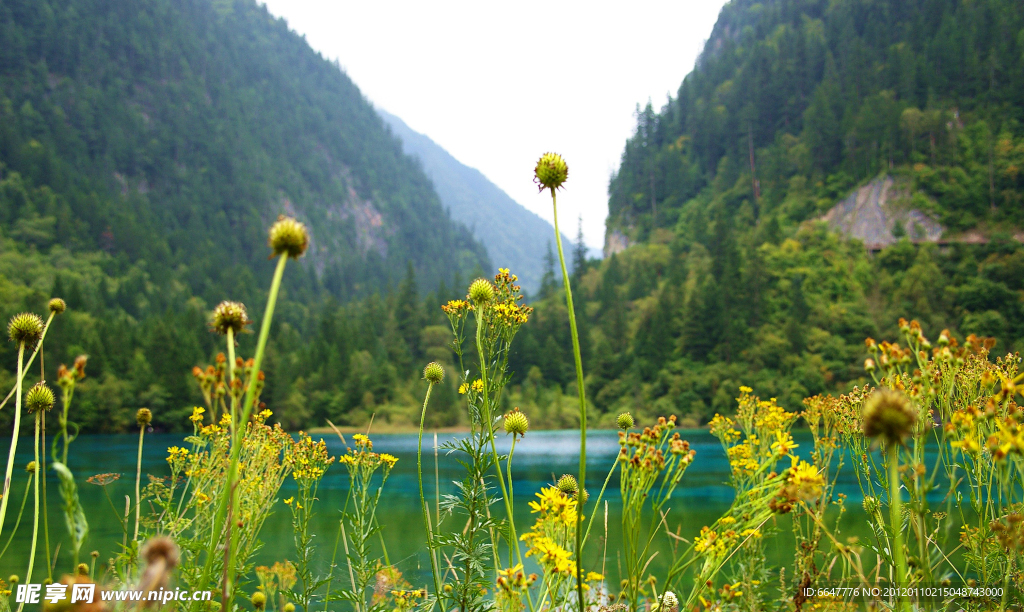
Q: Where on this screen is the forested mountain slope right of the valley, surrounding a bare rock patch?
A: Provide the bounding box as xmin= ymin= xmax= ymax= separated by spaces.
xmin=499 ymin=0 xmax=1024 ymax=423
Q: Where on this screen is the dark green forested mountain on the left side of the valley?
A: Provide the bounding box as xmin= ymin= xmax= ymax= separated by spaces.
xmin=0 ymin=0 xmax=489 ymax=429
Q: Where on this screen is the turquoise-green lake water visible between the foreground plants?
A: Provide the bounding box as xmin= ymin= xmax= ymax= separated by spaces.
xmin=0 ymin=430 xmax=864 ymax=584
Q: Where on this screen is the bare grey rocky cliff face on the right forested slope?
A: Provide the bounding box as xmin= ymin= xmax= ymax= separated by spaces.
xmin=821 ymin=176 xmax=944 ymax=250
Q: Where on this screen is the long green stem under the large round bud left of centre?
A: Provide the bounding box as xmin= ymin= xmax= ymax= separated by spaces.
xmin=198 ymin=255 xmax=288 ymax=610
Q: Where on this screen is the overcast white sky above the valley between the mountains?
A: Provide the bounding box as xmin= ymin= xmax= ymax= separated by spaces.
xmin=265 ymin=0 xmax=725 ymax=247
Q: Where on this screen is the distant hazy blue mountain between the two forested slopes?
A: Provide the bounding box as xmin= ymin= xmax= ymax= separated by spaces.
xmin=377 ymin=108 xmax=575 ymax=292
